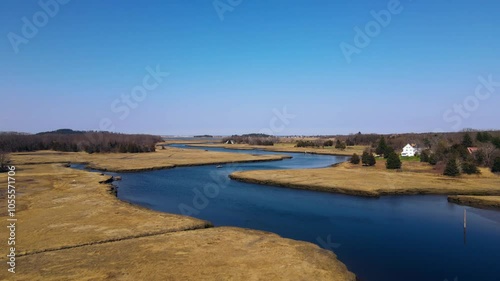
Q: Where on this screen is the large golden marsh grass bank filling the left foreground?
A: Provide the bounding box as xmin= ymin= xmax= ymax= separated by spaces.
xmin=0 ymin=150 xmax=355 ymax=280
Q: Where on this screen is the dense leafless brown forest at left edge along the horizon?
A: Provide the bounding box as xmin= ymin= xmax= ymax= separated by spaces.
xmin=0 ymin=129 xmax=162 ymax=153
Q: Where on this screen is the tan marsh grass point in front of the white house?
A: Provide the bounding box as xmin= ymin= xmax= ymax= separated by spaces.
xmin=230 ymin=161 xmax=500 ymax=197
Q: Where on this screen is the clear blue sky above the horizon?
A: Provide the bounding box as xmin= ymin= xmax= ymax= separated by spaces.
xmin=0 ymin=0 xmax=500 ymax=135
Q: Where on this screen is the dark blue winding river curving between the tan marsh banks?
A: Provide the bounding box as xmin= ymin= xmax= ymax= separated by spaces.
xmin=110 ymin=145 xmax=500 ymax=281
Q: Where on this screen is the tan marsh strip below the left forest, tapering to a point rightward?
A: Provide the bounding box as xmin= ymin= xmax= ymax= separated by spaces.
xmin=11 ymin=147 xmax=290 ymax=172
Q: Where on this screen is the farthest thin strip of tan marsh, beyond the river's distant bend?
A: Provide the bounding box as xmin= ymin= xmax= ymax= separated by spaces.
xmin=163 ymin=140 xmax=366 ymax=156
